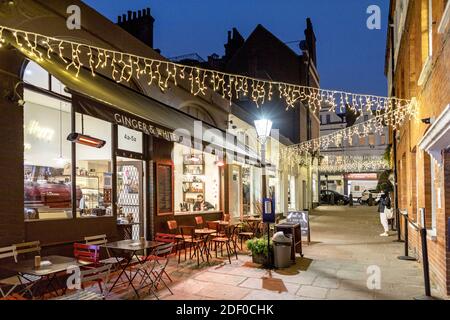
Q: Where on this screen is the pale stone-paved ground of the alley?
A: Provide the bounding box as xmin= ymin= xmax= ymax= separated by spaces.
xmin=149 ymin=206 xmax=424 ymax=300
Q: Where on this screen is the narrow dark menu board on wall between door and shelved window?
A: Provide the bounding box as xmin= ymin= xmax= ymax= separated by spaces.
xmin=156 ymin=163 xmax=173 ymax=215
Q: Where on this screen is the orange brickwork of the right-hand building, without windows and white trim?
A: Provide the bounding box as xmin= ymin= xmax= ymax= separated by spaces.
xmin=393 ymin=0 xmax=450 ymax=295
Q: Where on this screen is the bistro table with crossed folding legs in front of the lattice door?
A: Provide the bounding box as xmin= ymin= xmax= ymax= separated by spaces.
xmin=102 ymin=240 xmax=164 ymax=298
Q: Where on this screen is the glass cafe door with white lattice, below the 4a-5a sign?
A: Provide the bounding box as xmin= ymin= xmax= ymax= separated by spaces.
xmin=117 ymin=157 xmax=146 ymax=240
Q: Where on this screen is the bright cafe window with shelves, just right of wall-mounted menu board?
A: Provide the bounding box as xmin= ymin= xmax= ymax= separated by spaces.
xmin=173 ymin=143 xmax=220 ymax=214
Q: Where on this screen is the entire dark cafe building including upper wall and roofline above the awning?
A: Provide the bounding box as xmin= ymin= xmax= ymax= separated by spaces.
xmin=0 ymin=0 xmax=298 ymax=253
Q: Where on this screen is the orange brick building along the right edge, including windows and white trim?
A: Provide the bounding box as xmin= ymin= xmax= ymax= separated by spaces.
xmin=386 ymin=0 xmax=450 ymax=296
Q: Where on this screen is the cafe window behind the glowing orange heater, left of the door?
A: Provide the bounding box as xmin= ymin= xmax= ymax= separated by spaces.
xmin=76 ymin=113 xmax=112 ymax=217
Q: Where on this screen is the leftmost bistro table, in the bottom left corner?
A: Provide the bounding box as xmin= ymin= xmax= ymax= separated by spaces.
xmin=1 ymin=256 xmax=82 ymax=298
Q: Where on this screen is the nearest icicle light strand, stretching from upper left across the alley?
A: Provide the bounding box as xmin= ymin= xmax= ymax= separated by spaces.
xmin=0 ymin=25 xmax=410 ymax=117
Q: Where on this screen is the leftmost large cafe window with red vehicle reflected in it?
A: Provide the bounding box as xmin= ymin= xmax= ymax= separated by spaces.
xmin=24 ymin=90 xmax=72 ymax=220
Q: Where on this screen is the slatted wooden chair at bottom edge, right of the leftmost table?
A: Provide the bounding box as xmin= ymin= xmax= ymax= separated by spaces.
xmin=55 ymin=264 xmax=111 ymax=300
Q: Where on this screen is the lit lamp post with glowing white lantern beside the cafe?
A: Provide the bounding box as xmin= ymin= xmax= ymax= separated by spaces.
xmin=255 ymin=119 xmax=275 ymax=267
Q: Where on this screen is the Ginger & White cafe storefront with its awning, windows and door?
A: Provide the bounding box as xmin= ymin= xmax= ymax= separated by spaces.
xmin=19 ymin=55 xmax=260 ymax=244
